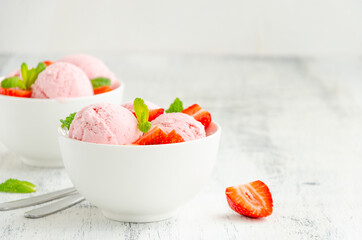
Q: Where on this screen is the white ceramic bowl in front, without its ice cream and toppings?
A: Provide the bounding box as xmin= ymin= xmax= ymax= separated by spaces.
xmin=59 ymin=122 xmax=221 ymax=222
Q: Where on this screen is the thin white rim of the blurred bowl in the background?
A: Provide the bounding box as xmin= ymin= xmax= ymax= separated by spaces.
xmin=0 ymin=76 xmax=125 ymax=103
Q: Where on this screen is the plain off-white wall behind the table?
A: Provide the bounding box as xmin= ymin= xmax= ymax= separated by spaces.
xmin=0 ymin=0 xmax=362 ymax=56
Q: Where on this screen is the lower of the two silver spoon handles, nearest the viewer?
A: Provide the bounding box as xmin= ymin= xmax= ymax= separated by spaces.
xmin=24 ymin=193 xmax=84 ymax=218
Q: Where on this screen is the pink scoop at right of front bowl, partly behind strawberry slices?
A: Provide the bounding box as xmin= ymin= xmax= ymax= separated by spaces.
xmin=152 ymin=113 xmax=206 ymax=141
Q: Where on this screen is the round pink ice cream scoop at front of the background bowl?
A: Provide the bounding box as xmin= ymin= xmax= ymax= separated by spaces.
xmin=31 ymin=63 xmax=93 ymax=98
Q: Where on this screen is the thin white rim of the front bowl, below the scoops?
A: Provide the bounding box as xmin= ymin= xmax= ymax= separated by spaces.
xmin=58 ymin=121 xmax=221 ymax=149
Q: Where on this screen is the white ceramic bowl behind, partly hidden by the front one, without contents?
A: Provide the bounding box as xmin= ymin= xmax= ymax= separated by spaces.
xmin=0 ymin=79 xmax=124 ymax=167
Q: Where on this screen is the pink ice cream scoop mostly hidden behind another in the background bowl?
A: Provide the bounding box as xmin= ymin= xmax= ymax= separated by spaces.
xmin=58 ymin=54 xmax=119 ymax=86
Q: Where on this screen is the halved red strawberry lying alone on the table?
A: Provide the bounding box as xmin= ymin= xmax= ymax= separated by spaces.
xmin=225 ymin=180 xmax=273 ymax=218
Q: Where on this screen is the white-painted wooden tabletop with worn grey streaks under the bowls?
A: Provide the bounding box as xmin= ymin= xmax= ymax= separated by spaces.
xmin=0 ymin=54 xmax=362 ymax=239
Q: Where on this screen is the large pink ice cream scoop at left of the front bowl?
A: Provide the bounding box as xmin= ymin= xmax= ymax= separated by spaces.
xmin=69 ymin=103 xmax=142 ymax=145
